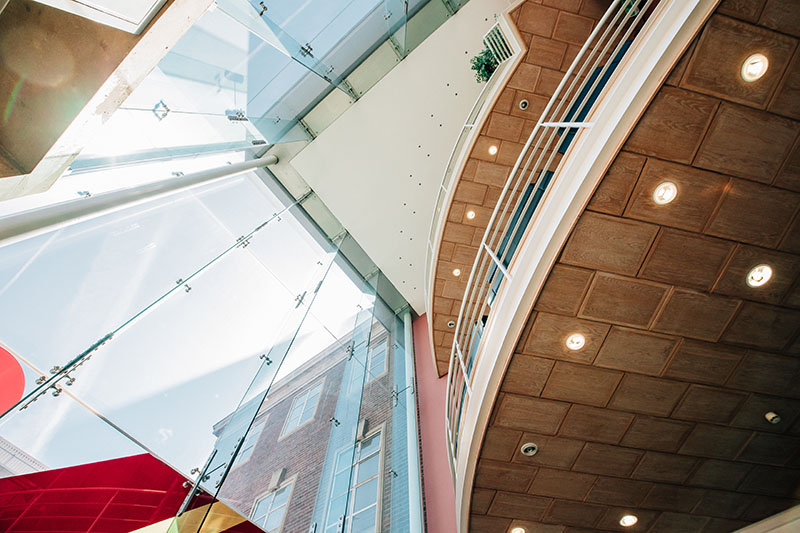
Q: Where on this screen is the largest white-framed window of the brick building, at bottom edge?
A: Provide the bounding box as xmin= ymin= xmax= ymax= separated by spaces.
xmin=325 ymin=431 xmax=382 ymax=533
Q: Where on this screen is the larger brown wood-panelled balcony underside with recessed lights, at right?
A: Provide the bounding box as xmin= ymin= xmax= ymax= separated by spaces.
xmin=470 ymin=0 xmax=800 ymax=532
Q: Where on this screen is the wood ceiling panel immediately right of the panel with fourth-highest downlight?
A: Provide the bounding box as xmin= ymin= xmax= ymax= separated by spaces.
xmin=594 ymin=326 xmax=678 ymax=376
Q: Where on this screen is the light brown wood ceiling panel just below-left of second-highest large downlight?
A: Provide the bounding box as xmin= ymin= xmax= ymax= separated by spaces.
xmin=561 ymin=213 xmax=658 ymax=276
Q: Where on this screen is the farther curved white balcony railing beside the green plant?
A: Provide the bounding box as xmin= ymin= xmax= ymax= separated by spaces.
xmin=425 ymin=22 xmax=522 ymax=312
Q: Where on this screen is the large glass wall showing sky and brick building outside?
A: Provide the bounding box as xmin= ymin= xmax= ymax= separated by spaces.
xmin=0 ymin=168 xmax=420 ymax=532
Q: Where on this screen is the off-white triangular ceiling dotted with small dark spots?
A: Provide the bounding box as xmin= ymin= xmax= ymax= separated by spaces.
xmin=291 ymin=0 xmax=510 ymax=314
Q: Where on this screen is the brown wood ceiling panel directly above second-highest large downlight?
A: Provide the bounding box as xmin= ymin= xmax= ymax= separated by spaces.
xmin=625 ymin=87 xmax=717 ymax=163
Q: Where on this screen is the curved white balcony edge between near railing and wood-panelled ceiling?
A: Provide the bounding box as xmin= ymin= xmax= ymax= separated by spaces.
xmin=456 ymin=0 xmax=717 ymax=532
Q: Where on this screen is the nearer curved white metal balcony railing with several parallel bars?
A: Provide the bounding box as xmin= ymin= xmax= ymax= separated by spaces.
xmin=447 ymin=0 xmax=658 ymax=475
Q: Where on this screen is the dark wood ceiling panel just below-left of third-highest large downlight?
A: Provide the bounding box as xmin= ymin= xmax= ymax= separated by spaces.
xmin=653 ymin=289 xmax=741 ymax=341
